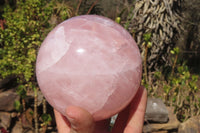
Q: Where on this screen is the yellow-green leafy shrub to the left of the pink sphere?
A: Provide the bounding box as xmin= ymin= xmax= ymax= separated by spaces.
xmin=0 ymin=0 xmax=52 ymax=84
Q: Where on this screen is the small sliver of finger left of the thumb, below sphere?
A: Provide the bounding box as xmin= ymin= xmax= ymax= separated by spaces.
xmin=54 ymin=109 xmax=70 ymax=133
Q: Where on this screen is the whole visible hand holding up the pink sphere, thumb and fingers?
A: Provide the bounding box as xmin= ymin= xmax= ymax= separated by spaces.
xmin=54 ymin=87 xmax=147 ymax=133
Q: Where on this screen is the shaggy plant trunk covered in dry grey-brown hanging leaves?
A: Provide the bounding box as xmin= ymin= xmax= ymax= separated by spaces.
xmin=130 ymin=0 xmax=181 ymax=70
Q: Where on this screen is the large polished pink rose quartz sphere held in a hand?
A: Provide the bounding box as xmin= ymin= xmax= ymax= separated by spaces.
xmin=36 ymin=15 xmax=142 ymax=121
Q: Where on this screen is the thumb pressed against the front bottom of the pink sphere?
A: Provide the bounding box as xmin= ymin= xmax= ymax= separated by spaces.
xmin=66 ymin=106 xmax=95 ymax=133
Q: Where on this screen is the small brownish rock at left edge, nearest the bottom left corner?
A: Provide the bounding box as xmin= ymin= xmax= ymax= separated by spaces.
xmin=0 ymin=112 xmax=11 ymax=129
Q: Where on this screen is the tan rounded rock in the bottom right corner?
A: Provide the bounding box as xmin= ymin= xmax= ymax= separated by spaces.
xmin=178 ymin=116 xmax=200 ymax=133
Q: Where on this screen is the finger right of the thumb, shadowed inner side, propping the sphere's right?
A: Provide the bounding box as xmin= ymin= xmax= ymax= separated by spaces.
xmin=112 ymin=87 xmax=147 ymax=133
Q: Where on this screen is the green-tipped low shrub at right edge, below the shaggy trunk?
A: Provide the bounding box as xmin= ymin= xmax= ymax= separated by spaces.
xmin=148 ymin=48 xmax=200 ymax=121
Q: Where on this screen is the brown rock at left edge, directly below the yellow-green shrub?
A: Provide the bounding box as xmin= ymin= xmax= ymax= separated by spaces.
xmin=0 ymin=90 xmax=19 ymax=111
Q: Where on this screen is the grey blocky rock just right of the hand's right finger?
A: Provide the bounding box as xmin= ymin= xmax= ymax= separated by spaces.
xmin=145 ymin=98 xmax=168 ymax=123
